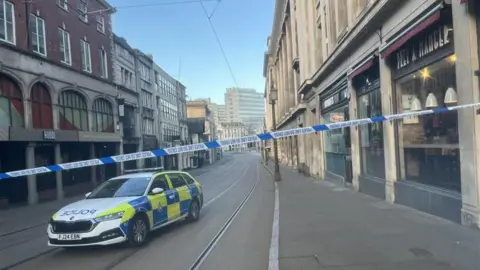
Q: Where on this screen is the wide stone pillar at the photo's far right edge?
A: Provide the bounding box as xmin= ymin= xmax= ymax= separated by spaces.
xmin=452 ymin=1 xmax=480 ymax=227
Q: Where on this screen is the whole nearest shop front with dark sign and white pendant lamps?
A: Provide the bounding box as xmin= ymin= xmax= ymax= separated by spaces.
xmin=388 ymin=5 xmax=462 ymax=222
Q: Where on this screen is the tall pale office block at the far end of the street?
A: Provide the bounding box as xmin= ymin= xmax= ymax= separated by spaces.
xmin=225 ymin=88 xmax=265 ymax=132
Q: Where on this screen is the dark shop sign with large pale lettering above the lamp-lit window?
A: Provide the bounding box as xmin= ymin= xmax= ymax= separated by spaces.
xmin=396 ymin=25 xmax=452 ymax=70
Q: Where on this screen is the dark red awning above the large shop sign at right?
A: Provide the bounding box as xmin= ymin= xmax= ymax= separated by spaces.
xmin=380 ymin=4 xmax=443 ymax=58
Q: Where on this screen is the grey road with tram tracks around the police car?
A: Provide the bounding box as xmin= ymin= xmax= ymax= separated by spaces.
xmin=0 ymin=153 xmax=274 ymax=270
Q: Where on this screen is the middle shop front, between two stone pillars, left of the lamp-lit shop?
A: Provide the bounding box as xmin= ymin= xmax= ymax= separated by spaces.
xmin=349 ymin=56 xmax=385 ymax=199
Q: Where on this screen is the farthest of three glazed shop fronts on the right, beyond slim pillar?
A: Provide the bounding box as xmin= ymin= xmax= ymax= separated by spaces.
xmin=320 ymin=76 xmax=352 ymax=183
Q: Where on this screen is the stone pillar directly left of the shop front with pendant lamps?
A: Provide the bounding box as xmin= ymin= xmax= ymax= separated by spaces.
xmin=379 ymin=57 xmax=398 ymax=203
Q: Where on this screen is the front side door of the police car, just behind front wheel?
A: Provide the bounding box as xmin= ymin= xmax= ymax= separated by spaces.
xmin=148 ymin=174 xmax=172 ymax=228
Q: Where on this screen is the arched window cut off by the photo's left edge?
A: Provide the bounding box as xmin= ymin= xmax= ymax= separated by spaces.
xmin=0 ymin=75 xmax=24 ymax=127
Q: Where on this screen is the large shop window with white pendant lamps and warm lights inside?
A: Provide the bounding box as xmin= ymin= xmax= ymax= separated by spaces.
xmin=396 ymin=55 xmax=460 ymax=191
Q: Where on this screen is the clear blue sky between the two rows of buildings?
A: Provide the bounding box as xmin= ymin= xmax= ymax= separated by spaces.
xmin=109 ymin=0 xmax=274 ymax=103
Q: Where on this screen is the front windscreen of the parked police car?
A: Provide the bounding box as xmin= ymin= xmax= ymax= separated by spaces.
xmin=87 ymin=177 xmax=150 ymax=199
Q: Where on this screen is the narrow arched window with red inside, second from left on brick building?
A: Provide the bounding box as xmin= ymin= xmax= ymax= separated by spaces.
xmin=31 ymin=83 xmax=53 ymax=129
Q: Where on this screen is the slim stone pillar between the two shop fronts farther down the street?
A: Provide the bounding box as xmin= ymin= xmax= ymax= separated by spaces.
xmin=348 ymin=80 xmax=361 ymax=191
